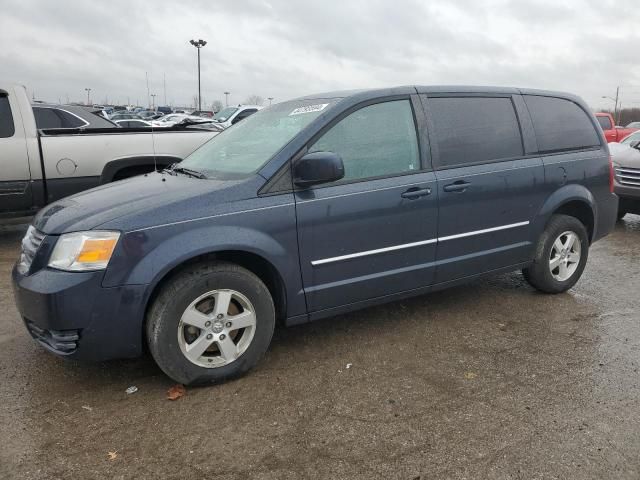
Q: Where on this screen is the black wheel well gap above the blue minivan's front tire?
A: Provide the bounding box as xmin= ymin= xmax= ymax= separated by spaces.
xmin=145 ymin=250 xmax=287 ymax=322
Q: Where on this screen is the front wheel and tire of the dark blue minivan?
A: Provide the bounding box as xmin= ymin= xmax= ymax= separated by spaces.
xmin=146 ymin=262 xmax=275 ymax=385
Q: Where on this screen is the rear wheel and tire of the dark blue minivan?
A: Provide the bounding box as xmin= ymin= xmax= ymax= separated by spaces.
xmin=522 ymin=215 xmax=589 ymax=293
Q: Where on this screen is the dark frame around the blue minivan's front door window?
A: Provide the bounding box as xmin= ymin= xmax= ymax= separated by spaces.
xmin=288 ymin=94 xmax=433 ymax=191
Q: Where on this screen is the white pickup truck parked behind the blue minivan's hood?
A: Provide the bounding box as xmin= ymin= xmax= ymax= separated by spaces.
xmin=0 ymin=83 xmax=218 ymax=218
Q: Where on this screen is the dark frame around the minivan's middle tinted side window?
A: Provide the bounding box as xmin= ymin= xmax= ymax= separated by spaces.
xmin=420 ymin=92 xmax=539 ymax=171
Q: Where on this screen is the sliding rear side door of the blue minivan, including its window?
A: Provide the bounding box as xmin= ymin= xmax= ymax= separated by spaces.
xmin=423 ymin=95 xmax=546 ymax=283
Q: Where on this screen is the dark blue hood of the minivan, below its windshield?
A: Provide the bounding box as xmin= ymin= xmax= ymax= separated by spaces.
xmin=33 ymin=173 xmax=255 ymax=234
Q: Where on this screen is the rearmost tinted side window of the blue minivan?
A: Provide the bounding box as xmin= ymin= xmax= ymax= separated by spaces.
xmin=523 ymin=95 xmax=600 ymax=153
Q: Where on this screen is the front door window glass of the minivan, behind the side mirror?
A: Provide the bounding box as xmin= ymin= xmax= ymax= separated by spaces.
xmin=309 ymin=100 xmax=420 ymax=180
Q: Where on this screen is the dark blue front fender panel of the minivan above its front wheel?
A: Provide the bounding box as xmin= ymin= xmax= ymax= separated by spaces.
xmin=103 ymin=204 xmax=306 ymax=315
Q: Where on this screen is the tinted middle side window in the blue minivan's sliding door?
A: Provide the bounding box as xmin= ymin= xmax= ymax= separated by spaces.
xmin=428 ymin=97 xmax=524 ymax=167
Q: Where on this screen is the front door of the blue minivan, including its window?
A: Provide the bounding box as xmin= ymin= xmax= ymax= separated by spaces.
xmin=295 ymin=96 xmax=438 ymax=312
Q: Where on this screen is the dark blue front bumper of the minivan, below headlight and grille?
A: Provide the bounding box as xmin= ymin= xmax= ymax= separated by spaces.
xmin=12 ymin=267 xmax=147 ymax=361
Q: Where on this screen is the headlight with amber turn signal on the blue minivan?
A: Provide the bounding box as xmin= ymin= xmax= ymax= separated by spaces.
xmin=49 ymin=231 xmax=120 ymax=272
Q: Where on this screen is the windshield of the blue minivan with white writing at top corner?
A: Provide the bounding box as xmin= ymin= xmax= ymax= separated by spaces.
xmin=180 ymin=99 xmax=337 ymax=179
